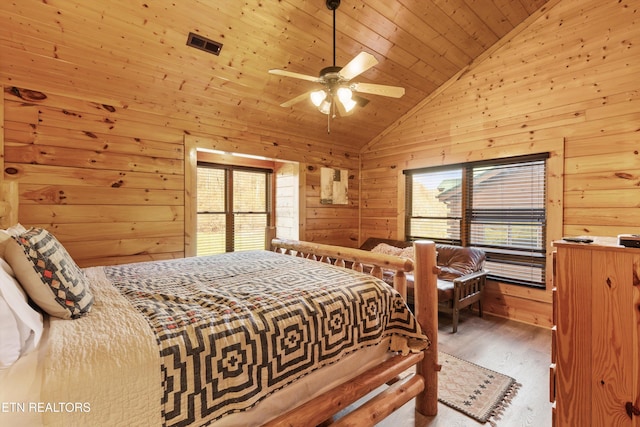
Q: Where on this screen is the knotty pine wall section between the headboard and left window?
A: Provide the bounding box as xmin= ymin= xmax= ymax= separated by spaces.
xmin=4 ymin=83 xmax=184 ymax=265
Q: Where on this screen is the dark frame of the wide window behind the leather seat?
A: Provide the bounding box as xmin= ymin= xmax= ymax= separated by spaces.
xmin=402 ymin=153 xmax=550 ymax=290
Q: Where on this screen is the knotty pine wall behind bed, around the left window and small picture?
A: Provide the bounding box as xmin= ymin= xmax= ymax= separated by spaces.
xmin=0 ymin=86 xmax=359 ymax=266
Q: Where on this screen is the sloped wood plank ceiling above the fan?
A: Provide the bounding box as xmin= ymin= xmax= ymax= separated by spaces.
xmin=0 ymin=0 xmax=547 ymax=151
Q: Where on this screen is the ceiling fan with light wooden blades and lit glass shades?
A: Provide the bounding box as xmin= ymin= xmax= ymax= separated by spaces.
xmin=269 ymin=0 xmax=404 ymax=132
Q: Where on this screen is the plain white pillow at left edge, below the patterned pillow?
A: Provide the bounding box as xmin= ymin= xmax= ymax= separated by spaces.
xmin=0 ymin=260 xmax=44 ymax=369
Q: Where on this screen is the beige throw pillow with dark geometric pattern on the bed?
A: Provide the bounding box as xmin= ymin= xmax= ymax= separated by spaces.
xmin=5 ymin=228 xmax=93 ymax=319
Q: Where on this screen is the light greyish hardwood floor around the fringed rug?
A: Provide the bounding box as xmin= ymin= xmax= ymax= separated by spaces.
xmin=378 ymin=310 xmax=551 ymax=427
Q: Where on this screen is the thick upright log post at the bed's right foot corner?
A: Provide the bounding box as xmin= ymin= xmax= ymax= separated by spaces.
xmin=413 ymin=240 xmax=441 ymax=416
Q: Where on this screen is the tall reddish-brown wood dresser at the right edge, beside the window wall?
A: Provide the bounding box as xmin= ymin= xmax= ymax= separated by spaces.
xmin=550 ymin=237 xmax=640 ymax=427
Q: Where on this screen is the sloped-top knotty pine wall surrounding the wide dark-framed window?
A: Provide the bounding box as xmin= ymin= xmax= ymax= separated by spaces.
xmin=361 ymin=0 xmax=640 ymax=325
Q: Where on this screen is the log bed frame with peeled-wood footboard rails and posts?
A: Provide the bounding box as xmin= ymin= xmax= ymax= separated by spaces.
xmin=0 ymin=180 xmax=441 ymax=427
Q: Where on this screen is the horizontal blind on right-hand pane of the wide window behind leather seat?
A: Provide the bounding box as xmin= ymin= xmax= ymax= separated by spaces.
xmin=467 ymin=160 xmax=546 ymax=286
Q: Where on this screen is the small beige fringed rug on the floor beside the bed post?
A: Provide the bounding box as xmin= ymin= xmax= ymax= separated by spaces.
xmin=438 ymin=352 xmax=520 ymax=426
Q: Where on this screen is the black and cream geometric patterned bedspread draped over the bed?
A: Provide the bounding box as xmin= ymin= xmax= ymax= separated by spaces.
xmin=105 ymin=251 xmax=429 ymax=426
